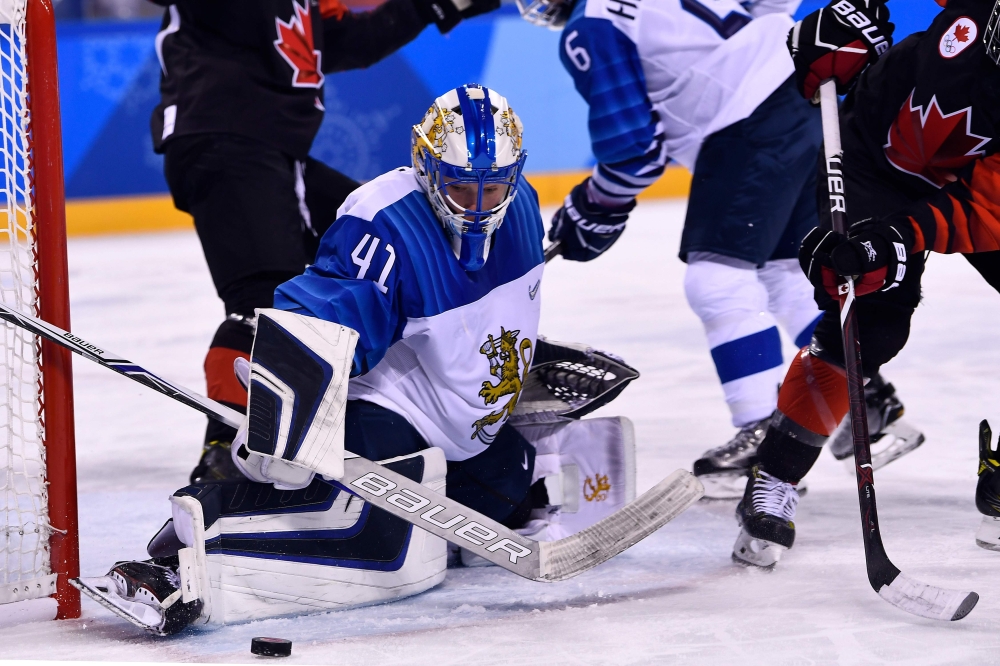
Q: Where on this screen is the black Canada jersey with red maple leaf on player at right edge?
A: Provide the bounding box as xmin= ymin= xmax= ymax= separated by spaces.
xmin=841 ymin=0 xmax=1000 ymax=252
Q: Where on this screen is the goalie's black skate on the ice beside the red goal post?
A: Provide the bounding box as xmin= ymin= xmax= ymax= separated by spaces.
xmin=70 ymin=560 xmax=204 ymax=636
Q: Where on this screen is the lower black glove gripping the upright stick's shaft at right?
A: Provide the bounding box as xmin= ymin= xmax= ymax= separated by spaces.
xmin=799 ymin=218 xmax=913 ymax=298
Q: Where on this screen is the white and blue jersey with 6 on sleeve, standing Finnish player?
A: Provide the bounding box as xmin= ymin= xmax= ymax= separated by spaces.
xmin=559 ymin=0 xmax=798 ymax=198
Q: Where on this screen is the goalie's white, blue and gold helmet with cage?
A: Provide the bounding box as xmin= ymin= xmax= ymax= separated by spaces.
xmin=412 ymin=83 xmax=527 ymax=271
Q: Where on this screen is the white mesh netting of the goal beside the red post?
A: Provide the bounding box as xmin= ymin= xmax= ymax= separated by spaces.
xmin=0 ymin=0 xmax=50 ymax=603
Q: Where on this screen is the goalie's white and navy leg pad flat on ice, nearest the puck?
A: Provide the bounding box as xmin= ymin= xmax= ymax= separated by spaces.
xmin=164 ymin=448 xmax=447 ymax=623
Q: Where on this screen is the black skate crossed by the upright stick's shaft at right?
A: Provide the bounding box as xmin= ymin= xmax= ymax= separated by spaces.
xmin=829 ymin=375 xmax=925 ymax=475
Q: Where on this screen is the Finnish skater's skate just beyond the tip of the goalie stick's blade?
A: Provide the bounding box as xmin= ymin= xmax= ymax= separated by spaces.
xmin=694 ymin=416 xmax=771 ymax=500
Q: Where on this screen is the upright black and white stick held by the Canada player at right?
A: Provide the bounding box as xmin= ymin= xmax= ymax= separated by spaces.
xmin=820 ymin=79 xmax=979 ymax=620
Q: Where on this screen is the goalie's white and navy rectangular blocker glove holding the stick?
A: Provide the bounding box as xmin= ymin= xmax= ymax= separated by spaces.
xmin=232 ymin=310 xmax=358 ymax=489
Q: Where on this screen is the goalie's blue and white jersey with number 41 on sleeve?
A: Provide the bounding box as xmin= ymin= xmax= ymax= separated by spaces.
xmin=275 ymin=167 xmax=545 ymax=460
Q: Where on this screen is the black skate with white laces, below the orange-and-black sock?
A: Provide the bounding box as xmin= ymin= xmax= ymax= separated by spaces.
xmin=733 ymin=466 xmax=799 ymax=568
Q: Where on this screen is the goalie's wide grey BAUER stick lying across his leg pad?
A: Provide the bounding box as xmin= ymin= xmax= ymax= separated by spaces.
xmin=0 ymin=304 xmax=704 ymax=581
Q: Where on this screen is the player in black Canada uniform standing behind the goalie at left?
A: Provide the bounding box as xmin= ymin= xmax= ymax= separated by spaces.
xmin=151 ymin=0 xmax=500 ymax=482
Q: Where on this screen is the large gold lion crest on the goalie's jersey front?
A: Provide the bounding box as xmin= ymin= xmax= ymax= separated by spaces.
xmin=472 ymin=326 xmax=532 ymax=444
